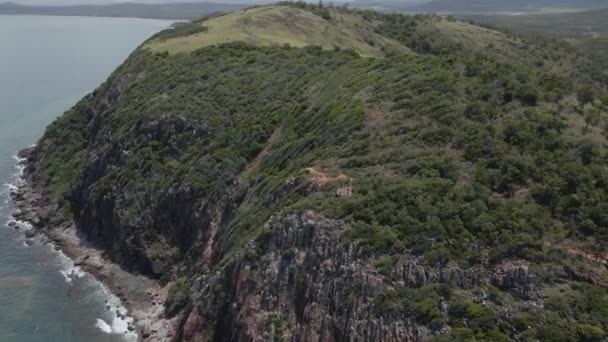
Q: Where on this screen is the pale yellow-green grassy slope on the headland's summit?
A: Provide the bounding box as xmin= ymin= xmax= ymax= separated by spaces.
xmin=146 ymin=6 xmax=407 ymax=56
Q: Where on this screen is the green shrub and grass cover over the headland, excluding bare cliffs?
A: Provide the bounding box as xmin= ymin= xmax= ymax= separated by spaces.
xmin=35 ymin=3 xmax=608 ymax=341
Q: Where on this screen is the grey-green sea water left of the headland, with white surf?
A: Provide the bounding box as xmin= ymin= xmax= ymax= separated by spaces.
xmin=0 ymin=15 xmax=169 ymax=342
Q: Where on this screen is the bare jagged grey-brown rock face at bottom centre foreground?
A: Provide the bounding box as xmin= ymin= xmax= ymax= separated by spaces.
xmin=177 ymin=212 xmax=431 ymax=341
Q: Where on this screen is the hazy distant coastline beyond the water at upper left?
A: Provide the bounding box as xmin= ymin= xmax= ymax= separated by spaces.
xmin=0 ymin=2 xmax=248 ymax=19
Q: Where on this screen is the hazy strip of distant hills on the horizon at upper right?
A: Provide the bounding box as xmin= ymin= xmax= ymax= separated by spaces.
xmin=410 ymin=0 xmax=608 ymax=13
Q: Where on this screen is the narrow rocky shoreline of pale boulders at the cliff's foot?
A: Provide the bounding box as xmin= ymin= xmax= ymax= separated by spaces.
xmin=8 ymin=148 xmax=176 ymax=342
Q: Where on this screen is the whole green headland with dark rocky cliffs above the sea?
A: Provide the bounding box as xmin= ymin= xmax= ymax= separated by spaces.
xmin=15 ymin=3 xmax=608 ymax=341
